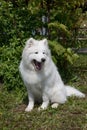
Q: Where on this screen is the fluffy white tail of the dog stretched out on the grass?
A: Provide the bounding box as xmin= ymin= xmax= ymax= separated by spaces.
xmin=66 ymin=86 xmax=85 ymax=98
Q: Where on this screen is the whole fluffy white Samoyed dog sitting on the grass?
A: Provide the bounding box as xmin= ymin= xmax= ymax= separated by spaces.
xmin=19 ymin=38 xmax=85 ymax=111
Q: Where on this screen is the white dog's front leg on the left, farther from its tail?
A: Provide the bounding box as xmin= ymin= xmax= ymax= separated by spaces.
xmin=25 ymin=93 xmax=34 ymax=112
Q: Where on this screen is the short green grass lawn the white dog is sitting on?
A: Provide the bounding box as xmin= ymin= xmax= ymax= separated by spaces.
xmin=0 ymin=55 xmax=87 ymax=130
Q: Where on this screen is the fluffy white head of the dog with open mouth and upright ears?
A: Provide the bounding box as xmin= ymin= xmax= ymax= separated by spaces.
xmin=22 ymin=38 xmax=50 ymax=71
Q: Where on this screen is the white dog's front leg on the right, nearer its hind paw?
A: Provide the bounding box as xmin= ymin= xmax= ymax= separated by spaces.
xmin=38 ymin=94 xmax=49 ymax=110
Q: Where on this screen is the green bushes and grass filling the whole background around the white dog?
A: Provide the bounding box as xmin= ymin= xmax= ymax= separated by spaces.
xmin=0 ymin=0 xmax=87 ymax=130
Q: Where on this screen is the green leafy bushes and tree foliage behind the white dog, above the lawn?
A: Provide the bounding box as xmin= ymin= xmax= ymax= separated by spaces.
xmin=0 ymin=0 xmax=83 ymax=90
